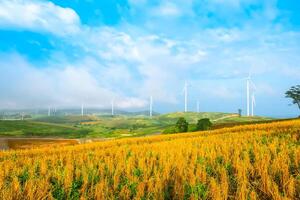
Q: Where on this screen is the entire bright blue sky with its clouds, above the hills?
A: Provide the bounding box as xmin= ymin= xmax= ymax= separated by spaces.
xmin=0 ymin=0 xmax=300 ymax=117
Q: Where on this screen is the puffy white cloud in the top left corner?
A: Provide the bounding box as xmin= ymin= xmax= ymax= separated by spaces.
xmin=0 ymin=0 xmax=80 ymax=36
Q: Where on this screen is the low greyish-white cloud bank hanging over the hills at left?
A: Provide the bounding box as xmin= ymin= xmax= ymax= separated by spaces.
xmin=0 ymin=54 xmax=146 ymax=109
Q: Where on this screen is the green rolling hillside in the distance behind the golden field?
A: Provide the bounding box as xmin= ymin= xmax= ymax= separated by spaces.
xmin=0 ymin=112 xmax=274 ymax=138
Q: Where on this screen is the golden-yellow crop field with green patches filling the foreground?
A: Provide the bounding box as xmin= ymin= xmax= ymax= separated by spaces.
xmin=0 ymin=120 xmax=300 ymax=199
